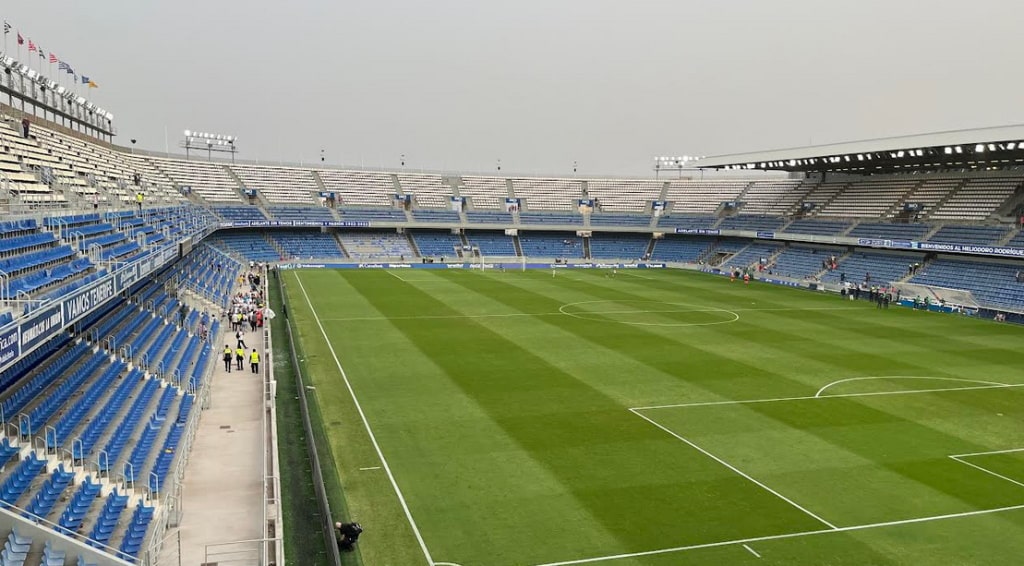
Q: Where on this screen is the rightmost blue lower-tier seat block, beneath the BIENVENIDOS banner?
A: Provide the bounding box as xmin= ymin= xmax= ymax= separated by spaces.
xmin=910 ymin=258 xmax=1024 ymax=309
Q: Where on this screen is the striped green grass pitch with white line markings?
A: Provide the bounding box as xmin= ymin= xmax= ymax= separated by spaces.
xmin=284 ymin=270 xmax=1024 ymax=566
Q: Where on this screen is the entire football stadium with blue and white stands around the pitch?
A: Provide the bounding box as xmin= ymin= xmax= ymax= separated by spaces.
xmin=0 ymin=3 xmax=1024 ymax=566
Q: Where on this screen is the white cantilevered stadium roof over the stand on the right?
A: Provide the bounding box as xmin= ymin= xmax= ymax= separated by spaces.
xmin=688 ymin=125 xmax=1024 ymax=175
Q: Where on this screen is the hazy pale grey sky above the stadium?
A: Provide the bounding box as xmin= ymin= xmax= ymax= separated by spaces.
xmin=0 ymin=0 xmax=1024 ymax=176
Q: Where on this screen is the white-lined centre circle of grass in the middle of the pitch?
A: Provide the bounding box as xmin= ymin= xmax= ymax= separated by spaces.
xmin=558 ymin=299 xmax=739 ymax=326
